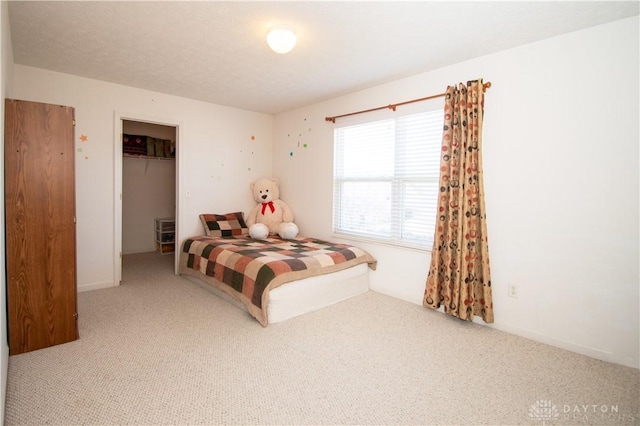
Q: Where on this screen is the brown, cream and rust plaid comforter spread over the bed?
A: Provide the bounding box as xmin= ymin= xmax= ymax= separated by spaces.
xmin=180 ymin=236 xmax=376 ymax=326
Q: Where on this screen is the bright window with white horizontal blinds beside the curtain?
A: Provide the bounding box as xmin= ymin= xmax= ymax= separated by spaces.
xmin=333 ymin=104 xmax=444 ymax=249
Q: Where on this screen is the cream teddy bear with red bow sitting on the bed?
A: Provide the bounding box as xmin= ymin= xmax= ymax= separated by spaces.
xmin=247 ymin=178 xmax=298 ymax=240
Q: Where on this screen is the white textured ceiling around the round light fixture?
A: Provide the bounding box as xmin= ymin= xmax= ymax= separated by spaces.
xmin=9 ymin=1 xmax=639 ymax=114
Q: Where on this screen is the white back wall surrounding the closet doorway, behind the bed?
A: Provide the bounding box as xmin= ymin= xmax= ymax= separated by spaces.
xmin=13 ymin=65 xmax=273 ymax=291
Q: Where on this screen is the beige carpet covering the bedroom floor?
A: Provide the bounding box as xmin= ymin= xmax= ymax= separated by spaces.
xmin=5 ymin=253 xmax=640 ymax=425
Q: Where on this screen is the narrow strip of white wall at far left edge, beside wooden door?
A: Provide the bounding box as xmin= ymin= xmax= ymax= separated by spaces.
xmin=0 ymin=1 xmax=13 ymax=424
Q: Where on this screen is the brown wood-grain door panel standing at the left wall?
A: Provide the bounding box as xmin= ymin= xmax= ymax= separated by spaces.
xmin=5 ymin=100 xmax=77 ymax=355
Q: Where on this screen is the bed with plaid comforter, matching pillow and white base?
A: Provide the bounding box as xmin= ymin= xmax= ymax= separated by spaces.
xmin=179 ymin=212 xmax=376 ymax=327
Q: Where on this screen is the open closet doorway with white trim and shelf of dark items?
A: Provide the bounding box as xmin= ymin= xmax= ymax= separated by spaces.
xmin=114 ymin=114 xmax=180 ymax=285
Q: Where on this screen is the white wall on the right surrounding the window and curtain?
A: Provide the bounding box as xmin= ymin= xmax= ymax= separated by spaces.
xmin=273 ymin=17 xmax=640 ymax=368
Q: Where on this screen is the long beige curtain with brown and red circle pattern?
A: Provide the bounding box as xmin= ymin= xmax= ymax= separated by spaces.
xmin=423 ymin=80 xmax=493 ymax=323
